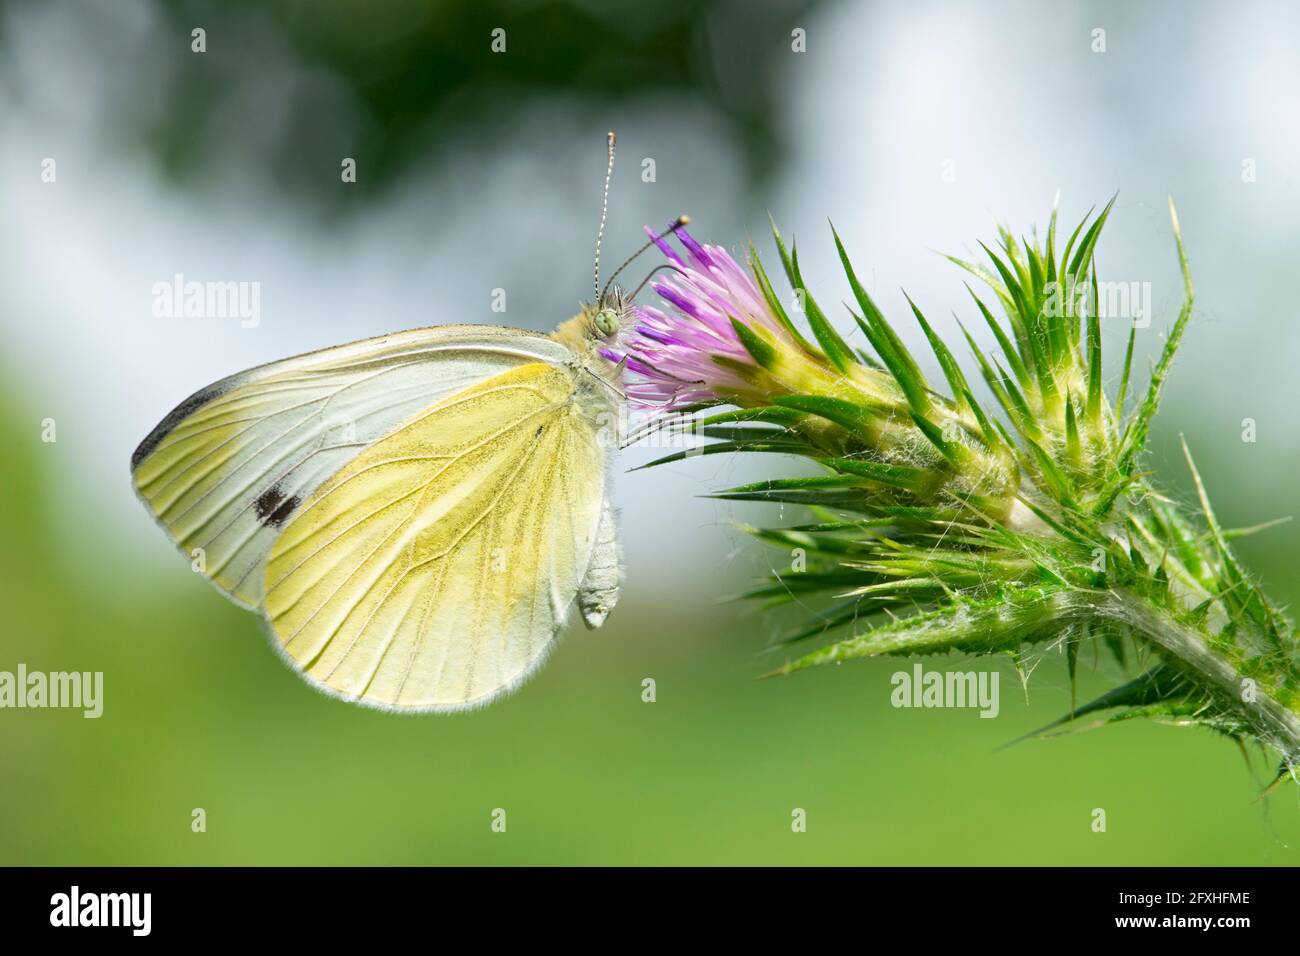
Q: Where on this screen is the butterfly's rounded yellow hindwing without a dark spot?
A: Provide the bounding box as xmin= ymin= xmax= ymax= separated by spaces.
xmin=264 ymin=363 xmax=612 ymax=710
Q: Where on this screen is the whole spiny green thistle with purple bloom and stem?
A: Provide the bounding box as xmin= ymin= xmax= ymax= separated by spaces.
xmin=607 ymin=200 xmax=1300 ymax=780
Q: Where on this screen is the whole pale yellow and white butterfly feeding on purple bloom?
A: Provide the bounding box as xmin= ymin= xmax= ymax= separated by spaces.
xmin=131 ymin=133 xmax=686 ymax=711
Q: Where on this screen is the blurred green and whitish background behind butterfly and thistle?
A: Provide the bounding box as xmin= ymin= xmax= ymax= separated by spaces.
xmin=0 ymin=0 xmax=1300 ymax=865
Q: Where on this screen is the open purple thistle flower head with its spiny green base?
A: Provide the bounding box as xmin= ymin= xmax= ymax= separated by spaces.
xmin=616 ymin=229 xmax=1019 ymax=520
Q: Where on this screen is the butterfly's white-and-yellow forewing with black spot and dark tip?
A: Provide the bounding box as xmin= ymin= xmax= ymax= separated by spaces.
xmin=131 ymin=325 xmax=569 ymax=607
